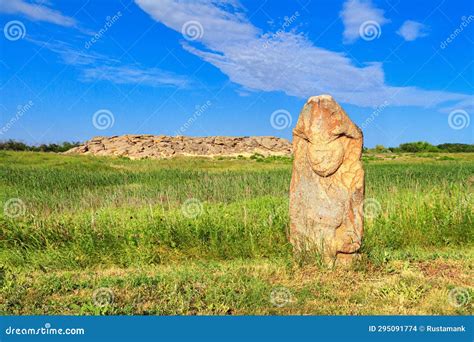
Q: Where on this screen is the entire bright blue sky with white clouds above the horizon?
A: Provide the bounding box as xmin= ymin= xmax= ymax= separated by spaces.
xmin=0 ymin=0 xmax=474 ymax=147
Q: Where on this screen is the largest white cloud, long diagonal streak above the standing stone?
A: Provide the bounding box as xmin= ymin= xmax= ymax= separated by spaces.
xmin=136 ymin=0 xmax=472 ymax=107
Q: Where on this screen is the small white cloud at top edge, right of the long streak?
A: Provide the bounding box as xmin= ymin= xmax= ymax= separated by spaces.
xmin=340 ymin=0 xmax=390 ymax=43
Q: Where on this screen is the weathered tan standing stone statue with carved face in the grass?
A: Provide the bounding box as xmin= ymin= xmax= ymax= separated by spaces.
xmin=290 ymin=95 xmax=364 ymax=264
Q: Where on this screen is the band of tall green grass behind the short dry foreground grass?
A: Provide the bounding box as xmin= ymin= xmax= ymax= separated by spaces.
xmin=0 ymin=152 xmax=474 ymax=269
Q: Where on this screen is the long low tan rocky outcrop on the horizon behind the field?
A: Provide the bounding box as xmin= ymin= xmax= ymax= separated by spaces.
xmin=66 ymin=135 xmax=291 ymax=159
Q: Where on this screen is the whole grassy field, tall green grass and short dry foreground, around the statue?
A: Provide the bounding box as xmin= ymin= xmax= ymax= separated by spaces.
xmin=0 ymin=152 xmax=474 ymax=315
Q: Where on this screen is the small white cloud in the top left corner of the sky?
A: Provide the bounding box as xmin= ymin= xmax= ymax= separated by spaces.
xmin=0 ymin=0 xmax=76 ymax=26
